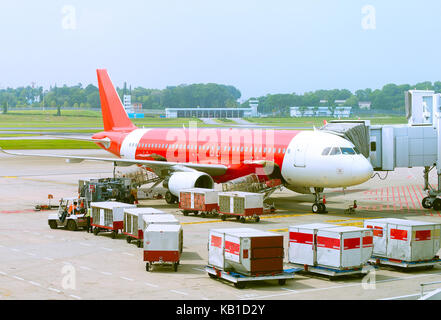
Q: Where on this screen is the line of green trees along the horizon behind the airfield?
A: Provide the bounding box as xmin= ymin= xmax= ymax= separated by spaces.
xmin=0 ymin=81 xmax=441 ymax=115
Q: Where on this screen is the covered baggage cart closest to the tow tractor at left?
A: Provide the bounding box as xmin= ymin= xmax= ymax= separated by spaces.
xmin=90 ymin=201 xmax=136 ymax=239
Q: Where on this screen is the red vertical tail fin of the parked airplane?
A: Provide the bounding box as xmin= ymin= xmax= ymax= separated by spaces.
xmin=96 ymin=69 xmax=136 ymax=131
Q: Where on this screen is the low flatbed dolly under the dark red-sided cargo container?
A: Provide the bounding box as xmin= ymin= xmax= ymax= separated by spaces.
xmin=205 ymin=266 xmax=301 ymax=289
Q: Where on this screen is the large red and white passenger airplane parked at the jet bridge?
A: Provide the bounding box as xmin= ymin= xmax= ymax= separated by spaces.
xmin=2 ymin=69 xmax=373 ymax=213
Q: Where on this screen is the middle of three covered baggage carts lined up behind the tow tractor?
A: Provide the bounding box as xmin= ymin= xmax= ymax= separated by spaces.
xmin=123 ymin=208 xmax=166 ymax=248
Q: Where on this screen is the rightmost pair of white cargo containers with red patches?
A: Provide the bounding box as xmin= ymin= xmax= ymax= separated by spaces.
xmin=364 ymin=218 xmax=441 ymax=262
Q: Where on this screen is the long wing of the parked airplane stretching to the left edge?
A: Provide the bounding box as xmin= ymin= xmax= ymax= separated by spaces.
xmin=0 ymin=147 xmax=228 ymax=176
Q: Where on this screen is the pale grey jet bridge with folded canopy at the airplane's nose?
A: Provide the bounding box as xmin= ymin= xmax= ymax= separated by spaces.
xmin=320 ymin=90 xmax=441 ymax=211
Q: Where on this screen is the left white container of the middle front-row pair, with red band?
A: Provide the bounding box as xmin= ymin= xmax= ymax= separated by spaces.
xmin=288 ymin=223 xmax=338 ymax=266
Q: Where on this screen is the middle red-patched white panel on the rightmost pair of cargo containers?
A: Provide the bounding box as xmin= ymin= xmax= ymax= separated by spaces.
xmin=387 ymin=223 xmax=412 ymax=261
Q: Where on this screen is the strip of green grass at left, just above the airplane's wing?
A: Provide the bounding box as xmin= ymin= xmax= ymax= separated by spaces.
xmin=0 ymin=139 xmax=100 ymax=150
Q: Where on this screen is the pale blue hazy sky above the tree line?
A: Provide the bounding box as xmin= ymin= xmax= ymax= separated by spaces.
xmin=0 ymin=0 xmax=441 ymax=99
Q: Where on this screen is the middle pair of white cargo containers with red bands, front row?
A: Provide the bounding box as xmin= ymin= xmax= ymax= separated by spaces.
xmin=288 ymin=224 xmax=373 ymax=270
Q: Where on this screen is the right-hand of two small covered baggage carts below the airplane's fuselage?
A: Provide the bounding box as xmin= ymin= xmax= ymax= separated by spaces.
xmin=219 ymin=191 xmax=264 ymax=223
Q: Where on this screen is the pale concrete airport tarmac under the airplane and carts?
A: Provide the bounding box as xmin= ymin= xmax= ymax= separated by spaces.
xmin=0 ymin=150 xmax=441 ymax=300
